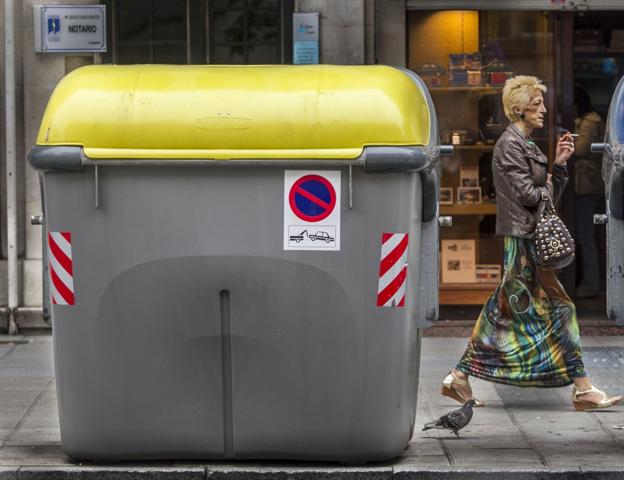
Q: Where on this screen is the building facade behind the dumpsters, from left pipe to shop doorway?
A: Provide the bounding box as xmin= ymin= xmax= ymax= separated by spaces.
xmin=0 ymin=0 xmax=624 ymax=328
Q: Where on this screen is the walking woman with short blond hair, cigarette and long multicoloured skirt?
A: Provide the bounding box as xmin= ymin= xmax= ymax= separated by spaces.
xmin=442 ymin=76 xmax=621 ymax=410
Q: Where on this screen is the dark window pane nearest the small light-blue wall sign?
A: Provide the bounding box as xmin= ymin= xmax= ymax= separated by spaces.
xmin=209 ymin=0 xmax=293 ymax=64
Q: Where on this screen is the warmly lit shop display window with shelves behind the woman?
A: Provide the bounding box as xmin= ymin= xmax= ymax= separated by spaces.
xmin=408 ymin=10 xmax=556 ymax=305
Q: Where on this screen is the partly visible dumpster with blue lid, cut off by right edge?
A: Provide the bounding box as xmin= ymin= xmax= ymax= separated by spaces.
xmin=592 ymin=77 xmax=624 ymax=325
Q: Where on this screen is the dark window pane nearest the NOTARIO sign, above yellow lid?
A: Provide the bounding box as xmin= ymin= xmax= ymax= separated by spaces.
xmin=104 ymin=0 xmax=205 ymax=64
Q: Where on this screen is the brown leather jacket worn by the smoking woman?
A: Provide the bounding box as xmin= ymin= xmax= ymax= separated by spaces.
xmin=492 ymin=124 xmax=568 ymax=238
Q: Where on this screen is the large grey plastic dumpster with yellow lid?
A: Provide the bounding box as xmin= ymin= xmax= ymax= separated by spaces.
xmin=29 ymin=65 xmax=448 ymax=461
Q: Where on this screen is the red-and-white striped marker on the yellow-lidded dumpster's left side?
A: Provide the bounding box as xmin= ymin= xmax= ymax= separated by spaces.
xmin=48 ymin=232 xmax=74 ymax=305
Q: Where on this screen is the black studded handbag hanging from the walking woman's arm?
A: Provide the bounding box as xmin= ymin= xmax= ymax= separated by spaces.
xmin=534 ymin=192 xmax=575 ymax=269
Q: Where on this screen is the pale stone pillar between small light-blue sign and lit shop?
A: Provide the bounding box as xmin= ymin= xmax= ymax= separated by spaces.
xmin=295 ymin=0 xmax=366 ymax=65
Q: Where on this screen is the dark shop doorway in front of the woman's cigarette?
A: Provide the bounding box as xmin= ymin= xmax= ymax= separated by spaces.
xmin=561 ymin=11 xmax=624 ymax=320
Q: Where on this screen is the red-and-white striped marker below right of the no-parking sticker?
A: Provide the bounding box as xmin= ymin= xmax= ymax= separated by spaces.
xmin=377 ymin=233 xmax=408 ymax=307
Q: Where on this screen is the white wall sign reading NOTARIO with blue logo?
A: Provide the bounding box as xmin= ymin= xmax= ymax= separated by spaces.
xmin=34 ymin=5 xmax=106 ymax=53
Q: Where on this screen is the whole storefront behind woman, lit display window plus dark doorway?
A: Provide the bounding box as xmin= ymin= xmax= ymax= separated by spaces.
xmin=407 ymin=9 xmax=624 ymax=318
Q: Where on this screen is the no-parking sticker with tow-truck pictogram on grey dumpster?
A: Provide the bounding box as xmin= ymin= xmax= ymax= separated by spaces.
xmin=284 ymin=170 xmax=340 ymax=251
